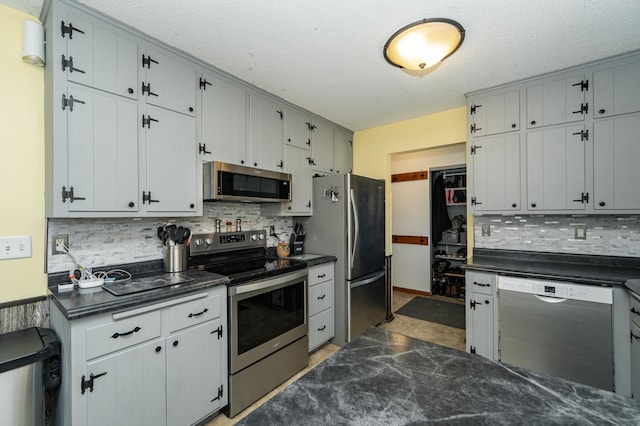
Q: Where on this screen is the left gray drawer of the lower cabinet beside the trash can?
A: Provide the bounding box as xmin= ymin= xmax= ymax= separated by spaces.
xmin=85 ymin=310 xmax=160 ymax=359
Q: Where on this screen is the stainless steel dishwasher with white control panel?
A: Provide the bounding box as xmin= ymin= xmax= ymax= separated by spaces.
xmin=498 ymin=277 xmax=613 ymax=391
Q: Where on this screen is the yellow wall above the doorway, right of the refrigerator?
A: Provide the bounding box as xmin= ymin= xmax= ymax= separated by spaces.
xmin=353 ymin=107 xmax=467 ymax=254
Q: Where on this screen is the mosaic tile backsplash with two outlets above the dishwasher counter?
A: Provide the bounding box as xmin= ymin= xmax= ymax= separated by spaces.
xmin=474 ymin=215 xmax=640 ymax=257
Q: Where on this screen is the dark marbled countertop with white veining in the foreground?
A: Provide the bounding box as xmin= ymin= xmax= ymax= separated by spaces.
xmin=238 ymin=327 xmax=640 ymax=426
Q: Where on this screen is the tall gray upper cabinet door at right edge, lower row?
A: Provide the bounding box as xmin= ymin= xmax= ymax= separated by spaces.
xmin=593 ymin=116 xmax=640 ymax=210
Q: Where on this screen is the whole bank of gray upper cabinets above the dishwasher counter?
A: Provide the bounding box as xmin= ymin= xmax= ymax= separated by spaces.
xmin=467 ymin=51 xmax=640 ymax=214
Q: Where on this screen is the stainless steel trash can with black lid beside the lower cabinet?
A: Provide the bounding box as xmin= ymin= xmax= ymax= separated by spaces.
xmin=0 ymin=327 xmax=60 ymax=426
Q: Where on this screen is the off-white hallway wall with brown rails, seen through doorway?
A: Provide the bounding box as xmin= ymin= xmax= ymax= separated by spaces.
xmin=391 ymin=144 xmax=466 ymax=293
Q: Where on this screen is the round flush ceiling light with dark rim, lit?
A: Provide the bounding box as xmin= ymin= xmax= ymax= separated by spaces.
xmin=383 ymin=18 xmax=464 ymax=71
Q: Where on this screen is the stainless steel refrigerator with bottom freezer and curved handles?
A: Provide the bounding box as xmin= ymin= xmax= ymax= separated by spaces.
xmin=302 ymin=173 xmax=387 ymax=346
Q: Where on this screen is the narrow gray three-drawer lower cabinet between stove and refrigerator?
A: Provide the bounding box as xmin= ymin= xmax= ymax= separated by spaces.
xmin=308 ymin=262 xmax=335 ymax=352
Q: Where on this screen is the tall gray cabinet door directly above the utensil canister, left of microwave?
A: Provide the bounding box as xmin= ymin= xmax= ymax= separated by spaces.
xmin=142 ymin=105 xmax=202 ymax=212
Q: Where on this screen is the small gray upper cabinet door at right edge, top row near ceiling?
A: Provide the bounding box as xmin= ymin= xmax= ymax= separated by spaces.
xmin=593 ymin=62 xmax=640 ymax=118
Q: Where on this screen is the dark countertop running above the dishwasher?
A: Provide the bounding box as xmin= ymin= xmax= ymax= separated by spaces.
xmin=463 ymin=248 xmax=640 ymax=286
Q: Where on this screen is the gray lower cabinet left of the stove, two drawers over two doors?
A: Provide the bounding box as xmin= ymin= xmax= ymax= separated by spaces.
xmin=51 ymin=286 xmax=228 ymax=426
